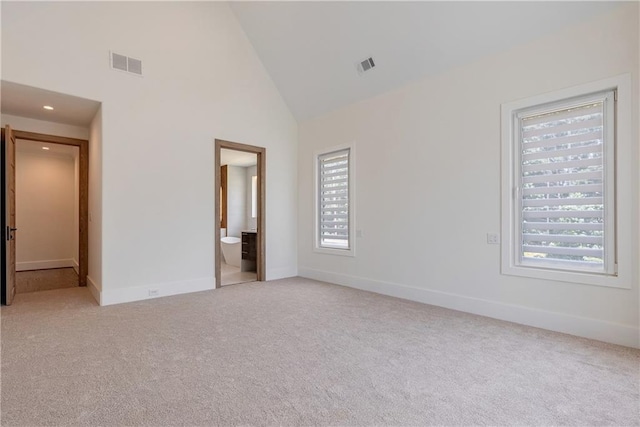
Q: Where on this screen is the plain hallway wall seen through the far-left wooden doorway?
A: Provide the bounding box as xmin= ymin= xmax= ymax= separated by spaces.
xmin=16 ymin=147 xmax=78 ymax=271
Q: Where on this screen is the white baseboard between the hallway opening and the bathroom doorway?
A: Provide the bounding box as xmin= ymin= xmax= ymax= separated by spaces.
xmin=99 ymin=277 xmax=216 ymax=305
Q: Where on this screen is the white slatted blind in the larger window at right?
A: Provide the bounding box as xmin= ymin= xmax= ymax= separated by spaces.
xmin=516 ymin=91 xmax=615 ymax=274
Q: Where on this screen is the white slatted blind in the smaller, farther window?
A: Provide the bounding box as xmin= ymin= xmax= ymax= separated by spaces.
xmin=317 ymin=148 xmax=350 ymax=249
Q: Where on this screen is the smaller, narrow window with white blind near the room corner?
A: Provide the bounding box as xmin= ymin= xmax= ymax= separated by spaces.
xmin=316 ymin=145 xmax=354 ymax=255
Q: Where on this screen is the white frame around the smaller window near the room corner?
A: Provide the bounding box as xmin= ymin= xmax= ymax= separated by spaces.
xmin=313 ymin=142 xmax=356 ymax=257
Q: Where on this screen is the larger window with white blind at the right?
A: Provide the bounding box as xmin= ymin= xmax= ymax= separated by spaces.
xmin=502 ymin=80 xmax=617 ymax=284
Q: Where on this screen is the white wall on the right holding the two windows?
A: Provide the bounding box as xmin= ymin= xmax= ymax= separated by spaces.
xmin=298 ymin=3 xmax=640 ymax=346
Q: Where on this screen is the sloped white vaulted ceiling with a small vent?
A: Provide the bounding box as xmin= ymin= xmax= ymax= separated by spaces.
xmin=231 ymin=1 xmax=620 ymax=120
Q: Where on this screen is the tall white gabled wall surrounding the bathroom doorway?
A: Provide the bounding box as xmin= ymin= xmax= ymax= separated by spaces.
xmin=2 ymin=2 xmax=297 ymax=304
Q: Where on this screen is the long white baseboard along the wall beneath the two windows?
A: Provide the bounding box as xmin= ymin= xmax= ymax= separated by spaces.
xmin=298 ymin=267 xmax=640 ymax=348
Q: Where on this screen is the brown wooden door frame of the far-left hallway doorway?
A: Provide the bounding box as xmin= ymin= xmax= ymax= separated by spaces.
xmin=13 ymin=129 xmax=89 ymax=286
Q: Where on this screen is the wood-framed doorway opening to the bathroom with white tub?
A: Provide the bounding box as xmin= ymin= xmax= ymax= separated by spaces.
xmin=214 ymin=139 xmax=266 ymax=288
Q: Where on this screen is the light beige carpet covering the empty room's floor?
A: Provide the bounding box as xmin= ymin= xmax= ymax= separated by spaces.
xmin=1 ymin=278 xmax=640 ymax=426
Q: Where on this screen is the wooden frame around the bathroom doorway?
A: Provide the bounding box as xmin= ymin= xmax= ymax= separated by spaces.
xmin=214 ymin=139 xmax=267 ymax=289
